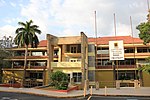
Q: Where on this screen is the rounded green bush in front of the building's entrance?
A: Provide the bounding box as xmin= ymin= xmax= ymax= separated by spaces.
xmin=50 ymin=71 xmax=69 ymax=90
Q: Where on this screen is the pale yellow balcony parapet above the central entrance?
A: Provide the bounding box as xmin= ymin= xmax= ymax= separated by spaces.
xmin=51 ymin=62 xmax=81 ymax=68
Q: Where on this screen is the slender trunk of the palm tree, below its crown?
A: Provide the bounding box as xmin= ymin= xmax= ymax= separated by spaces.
xmin=22 ymin=45 xmax=28 ymax=87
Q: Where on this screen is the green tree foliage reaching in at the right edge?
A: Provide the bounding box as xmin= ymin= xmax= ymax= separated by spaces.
xmin=136 ymin=12 xmax=150 ymax=74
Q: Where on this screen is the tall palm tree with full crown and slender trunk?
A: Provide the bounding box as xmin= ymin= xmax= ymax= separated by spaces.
xmin=14 ymin=20 xmax=41 ymax=85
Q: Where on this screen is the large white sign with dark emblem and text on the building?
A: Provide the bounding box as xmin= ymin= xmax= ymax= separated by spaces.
xmin=109 ymin=40 xmax=124 ymax=60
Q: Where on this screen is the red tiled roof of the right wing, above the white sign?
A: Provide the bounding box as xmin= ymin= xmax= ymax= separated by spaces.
xmin=88 ymin=36 xmax=143 ymax=45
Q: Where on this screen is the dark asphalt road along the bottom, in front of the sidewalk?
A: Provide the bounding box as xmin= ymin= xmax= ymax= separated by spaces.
xmin=0 ymin=92 xmax=150 ymax=100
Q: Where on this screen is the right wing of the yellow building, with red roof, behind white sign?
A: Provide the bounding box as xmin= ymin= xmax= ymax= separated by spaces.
xmin=88 ymin=36 xmax=150 ymax=87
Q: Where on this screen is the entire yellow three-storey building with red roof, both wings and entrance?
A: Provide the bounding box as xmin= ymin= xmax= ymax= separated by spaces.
xmin=2 ymin=32 xmax=150 ymax=87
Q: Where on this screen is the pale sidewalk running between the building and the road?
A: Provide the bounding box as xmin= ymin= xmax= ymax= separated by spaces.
xmin=0 ymin=87 xmax=150 ymax=98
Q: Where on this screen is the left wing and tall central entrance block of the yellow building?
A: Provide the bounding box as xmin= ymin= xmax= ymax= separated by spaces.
xmin=3 ymin=32 xmax=88 ymax=87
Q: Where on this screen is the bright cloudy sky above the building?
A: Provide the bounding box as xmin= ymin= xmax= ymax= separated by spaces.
xmin=0 ymin=0 xmax=148 ymax=40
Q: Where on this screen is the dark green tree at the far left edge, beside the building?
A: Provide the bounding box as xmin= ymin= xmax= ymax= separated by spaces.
xmin=0 ymin=48 xmax=11 ymax=83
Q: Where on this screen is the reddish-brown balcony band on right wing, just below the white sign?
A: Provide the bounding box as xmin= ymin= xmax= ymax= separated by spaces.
xmin=96 ymin=65 xmax=137 ymax=69
